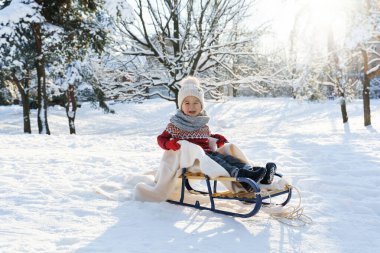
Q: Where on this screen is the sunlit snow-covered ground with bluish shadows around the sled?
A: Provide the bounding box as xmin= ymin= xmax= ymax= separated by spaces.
xmin=0 ymin=98 xmax=380 ymax=253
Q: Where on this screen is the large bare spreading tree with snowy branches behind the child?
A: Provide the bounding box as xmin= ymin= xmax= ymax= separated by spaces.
xmin=104 ymin=0 xmax=270 ymax=105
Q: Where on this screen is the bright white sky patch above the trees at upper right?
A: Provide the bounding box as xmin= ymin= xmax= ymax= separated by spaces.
xmin=251 ymin=0 xmax=362 ymax=59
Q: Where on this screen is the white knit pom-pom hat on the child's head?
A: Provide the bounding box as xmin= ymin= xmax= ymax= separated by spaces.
xmin=178 ymin=76 xmax=205 ymax=109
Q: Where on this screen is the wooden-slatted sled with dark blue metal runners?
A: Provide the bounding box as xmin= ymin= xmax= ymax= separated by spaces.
xmin=167 ymin=168 xmax=292 ymax=218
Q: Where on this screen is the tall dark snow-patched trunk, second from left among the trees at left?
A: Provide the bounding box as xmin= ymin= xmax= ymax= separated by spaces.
xmin=32 ymin=24 xmax=50 ymax=134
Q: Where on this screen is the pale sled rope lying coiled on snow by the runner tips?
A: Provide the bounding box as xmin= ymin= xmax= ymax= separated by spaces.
xmin=263 ymin=185 xmax=313 ymax=227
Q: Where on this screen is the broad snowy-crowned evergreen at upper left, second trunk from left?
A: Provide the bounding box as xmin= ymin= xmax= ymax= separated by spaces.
xmin=0 ymin=0 xmax=106 ymax=134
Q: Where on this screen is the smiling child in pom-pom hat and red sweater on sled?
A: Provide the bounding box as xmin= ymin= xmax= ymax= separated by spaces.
xmin=157 ymin=77 xmax=276 ymax=191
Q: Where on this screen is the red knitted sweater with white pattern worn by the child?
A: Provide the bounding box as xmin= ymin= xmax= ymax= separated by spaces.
xmin=157 ymin=123 xmax=214 ymax=152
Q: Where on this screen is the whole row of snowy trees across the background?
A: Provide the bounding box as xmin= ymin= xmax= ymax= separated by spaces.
xmin=0 ymin=0 xmax=380 ymax=134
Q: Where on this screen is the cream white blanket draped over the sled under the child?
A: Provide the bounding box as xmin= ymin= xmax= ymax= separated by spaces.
xmin=134 ymin=140 xmax=250 ymax=202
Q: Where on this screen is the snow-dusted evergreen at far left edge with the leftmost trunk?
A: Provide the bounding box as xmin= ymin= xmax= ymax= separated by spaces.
xmin=0 ymin=0 xmax=43 ymax=133
